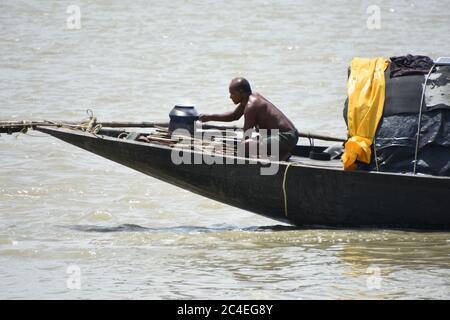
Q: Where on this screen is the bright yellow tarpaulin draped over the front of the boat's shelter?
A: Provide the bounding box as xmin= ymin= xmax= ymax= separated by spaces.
xmin=342 ymin=58 xmax=389 ymax=170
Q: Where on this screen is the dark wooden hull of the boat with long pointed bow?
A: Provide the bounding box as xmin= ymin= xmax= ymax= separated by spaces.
xmin=35 ymin=126 xmax=450 ymax=230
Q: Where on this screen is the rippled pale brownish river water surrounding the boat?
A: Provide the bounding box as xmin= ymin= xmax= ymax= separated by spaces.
xmin=0 ymin=0 xmax=450 ymax=299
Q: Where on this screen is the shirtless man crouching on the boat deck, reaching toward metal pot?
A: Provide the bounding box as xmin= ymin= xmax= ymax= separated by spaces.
xmin=199 ymin=78 xmax=298 ymax=160
